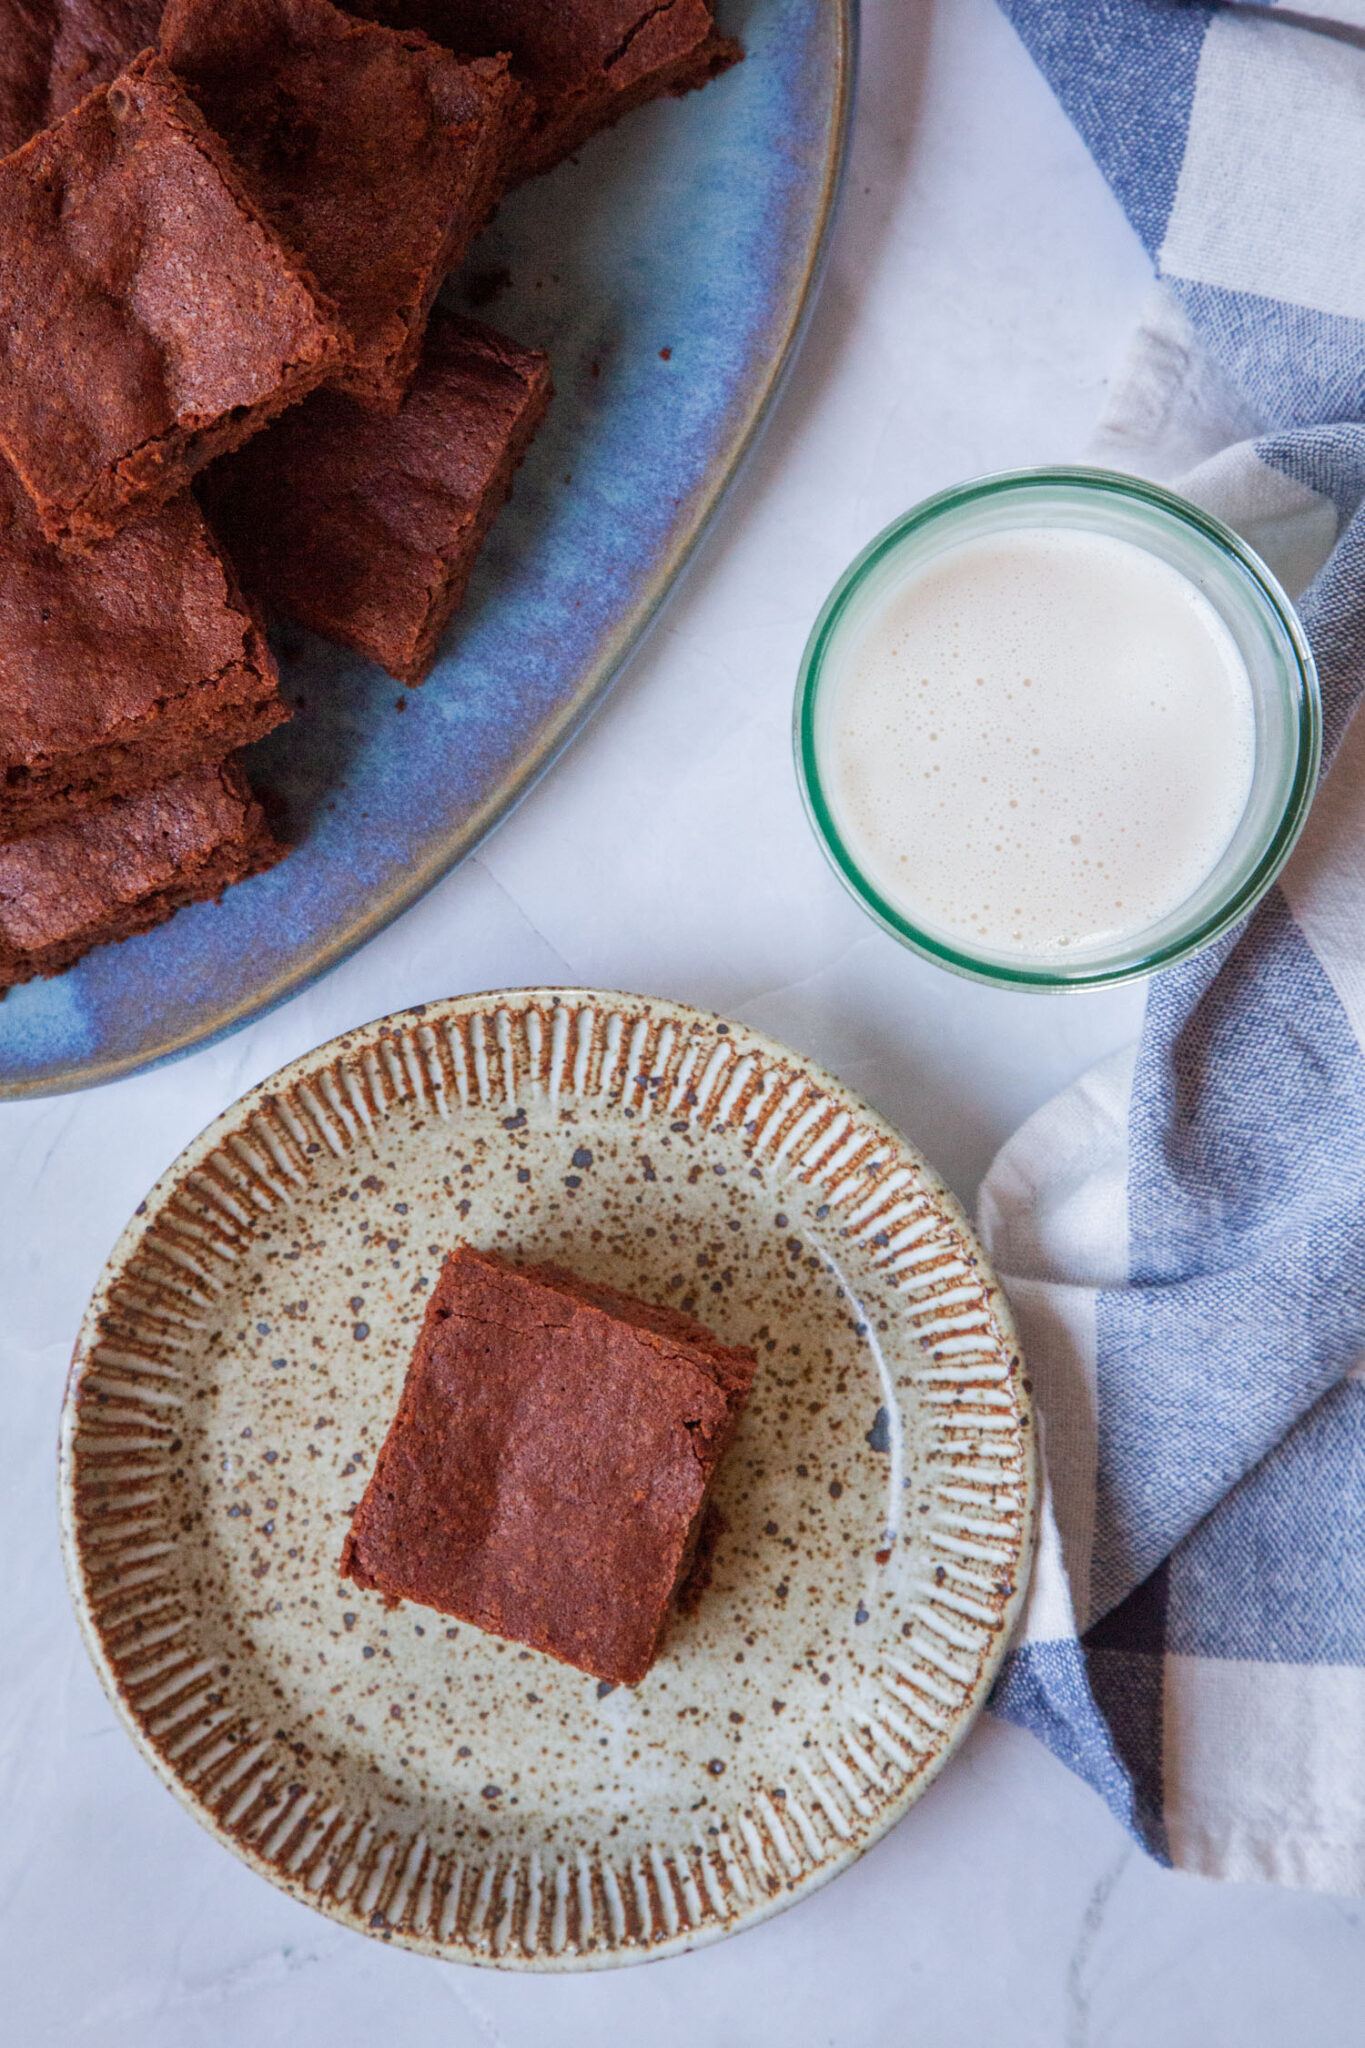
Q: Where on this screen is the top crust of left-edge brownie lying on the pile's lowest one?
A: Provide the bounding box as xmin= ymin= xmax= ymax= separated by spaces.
xmin=0 ymin=461 xmax=274 ymax=770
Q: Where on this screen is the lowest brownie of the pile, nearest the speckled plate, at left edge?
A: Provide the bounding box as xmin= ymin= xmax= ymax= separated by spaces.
xmin=0 ymin=762 xmax=284 ymax=991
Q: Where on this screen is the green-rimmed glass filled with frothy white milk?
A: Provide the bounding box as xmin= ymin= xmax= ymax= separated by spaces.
xmin=796 ymin=469 xmax=1320 ymax=989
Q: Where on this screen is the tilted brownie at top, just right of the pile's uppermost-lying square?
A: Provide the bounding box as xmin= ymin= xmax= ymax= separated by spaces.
xmin=162 ymin=0 xmax=528 ymax=410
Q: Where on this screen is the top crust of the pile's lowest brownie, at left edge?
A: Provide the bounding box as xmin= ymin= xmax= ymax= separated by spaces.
xmin=0 ymin=764 xmax=264 ymax=952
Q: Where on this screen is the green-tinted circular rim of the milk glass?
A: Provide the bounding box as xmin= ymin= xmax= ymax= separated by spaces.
xmin=792 ymin=467 xmax=1322 ymax=989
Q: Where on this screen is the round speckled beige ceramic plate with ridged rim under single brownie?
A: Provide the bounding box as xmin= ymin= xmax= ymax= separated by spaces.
xmin=61 ymin=989 xmax=1036 ymax=1970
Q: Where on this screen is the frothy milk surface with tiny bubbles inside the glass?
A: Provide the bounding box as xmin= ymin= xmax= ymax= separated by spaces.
xmin=821 ymin=526 xmax=1254 ymax=965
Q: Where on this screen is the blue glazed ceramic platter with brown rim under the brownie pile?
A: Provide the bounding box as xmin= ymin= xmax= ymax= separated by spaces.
xmin=0 ymin=0 xmax=853 ymax=1096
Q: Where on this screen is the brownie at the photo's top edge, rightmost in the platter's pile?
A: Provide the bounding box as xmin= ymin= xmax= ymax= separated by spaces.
xmin=347 ymin=0 xmax=741 ymax=180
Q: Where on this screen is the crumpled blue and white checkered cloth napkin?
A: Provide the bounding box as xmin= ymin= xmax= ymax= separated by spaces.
xmin=980 ymin=0 xmax=1365 ymax=1892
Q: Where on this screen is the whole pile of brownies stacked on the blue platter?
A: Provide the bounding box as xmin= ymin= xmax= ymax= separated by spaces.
xmin=0 ymin=0 xmax=737 ymax=991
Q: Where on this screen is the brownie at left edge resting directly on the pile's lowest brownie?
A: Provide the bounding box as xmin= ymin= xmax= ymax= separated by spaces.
xmin=0 ymin=463 xmax=289 ymax=842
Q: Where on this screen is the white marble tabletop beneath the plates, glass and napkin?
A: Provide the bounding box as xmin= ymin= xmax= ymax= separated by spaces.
xmin=0 ymin=0 xmax=1365 ymax=2048
